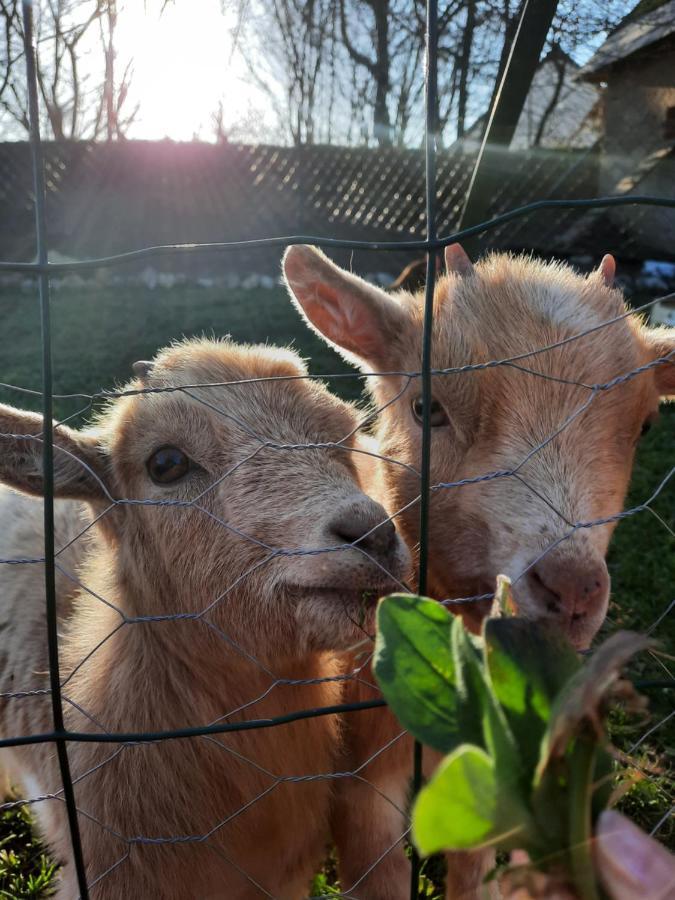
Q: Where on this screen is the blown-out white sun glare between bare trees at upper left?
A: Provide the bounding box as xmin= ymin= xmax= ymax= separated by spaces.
xmin=117 ymin=0 xmax=262 ymax=141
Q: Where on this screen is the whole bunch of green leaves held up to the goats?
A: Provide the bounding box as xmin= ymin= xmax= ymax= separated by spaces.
xmin=375 ymin=583 xmax=649 ymax=900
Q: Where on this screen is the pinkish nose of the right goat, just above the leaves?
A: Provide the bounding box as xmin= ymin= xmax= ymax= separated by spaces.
xmin=527 ymin=556 xmax=609 ymax=618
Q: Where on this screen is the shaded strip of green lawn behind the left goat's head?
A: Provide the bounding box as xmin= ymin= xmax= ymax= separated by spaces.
xmin=0 ymin=286 xmax=361 ymax=415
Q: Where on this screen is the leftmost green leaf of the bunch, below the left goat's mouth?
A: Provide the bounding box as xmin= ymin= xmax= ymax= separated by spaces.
xmin=373 ymin=594 xmax=460 ymax=753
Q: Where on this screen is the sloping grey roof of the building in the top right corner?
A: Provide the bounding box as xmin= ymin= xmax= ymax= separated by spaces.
xmin=577 ymin=0 xmax=675 ymax=81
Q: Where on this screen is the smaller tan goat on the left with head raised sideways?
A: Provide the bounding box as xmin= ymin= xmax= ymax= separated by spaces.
xmin=0 ymin=341 xmax=409 ymax=900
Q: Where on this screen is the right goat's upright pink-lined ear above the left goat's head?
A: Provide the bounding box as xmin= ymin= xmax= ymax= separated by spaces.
xmin=283 ymin=244 xmax=408 ymax=370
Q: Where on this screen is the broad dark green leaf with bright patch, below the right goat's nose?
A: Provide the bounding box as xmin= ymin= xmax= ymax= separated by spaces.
xmin=484 ymin=618 xmax=580 ymax=782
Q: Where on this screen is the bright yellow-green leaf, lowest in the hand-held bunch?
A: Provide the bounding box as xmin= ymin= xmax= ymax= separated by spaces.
xmin=412 ymin=744 xmax=530 ymax=856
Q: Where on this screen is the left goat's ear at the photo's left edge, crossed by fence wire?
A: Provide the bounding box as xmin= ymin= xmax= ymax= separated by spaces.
xmin=0 ymin=404 xmax=107 ymax=501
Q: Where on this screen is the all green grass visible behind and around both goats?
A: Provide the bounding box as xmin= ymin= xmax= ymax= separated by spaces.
xmin=0 ymin=284 xmax=675 ymax=898
